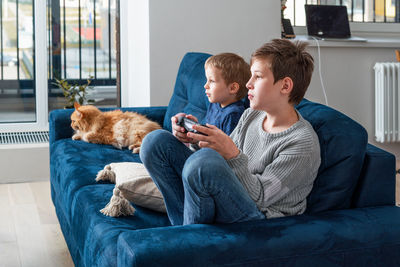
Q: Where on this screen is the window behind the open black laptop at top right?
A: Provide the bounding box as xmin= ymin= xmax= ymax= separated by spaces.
xmin=284 ymin=0 xmax=400 ymax=26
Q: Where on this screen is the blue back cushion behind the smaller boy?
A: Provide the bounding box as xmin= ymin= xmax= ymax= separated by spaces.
xmin=163 ymin=53 xmax=211 ymax=131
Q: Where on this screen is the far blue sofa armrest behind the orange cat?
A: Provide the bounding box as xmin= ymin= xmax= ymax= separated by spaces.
xmin=49 ymin=107 xmax=167 ymax=144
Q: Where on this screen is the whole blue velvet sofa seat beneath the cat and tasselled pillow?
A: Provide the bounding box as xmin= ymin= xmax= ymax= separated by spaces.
xmin=50 ymin=139 xmax=170 ymax=266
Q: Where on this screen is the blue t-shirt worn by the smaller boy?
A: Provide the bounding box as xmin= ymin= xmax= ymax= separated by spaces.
xmin=201 ymin=100 xmax=246 ymax=135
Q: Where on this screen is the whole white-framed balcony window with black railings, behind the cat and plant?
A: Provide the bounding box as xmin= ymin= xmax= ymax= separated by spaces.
xmin=0 ymin=0 xmax=119 ymax=132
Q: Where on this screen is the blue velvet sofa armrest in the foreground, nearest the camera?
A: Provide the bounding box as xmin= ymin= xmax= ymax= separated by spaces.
xmin=117 ymin=206 xmax=400 ymax=266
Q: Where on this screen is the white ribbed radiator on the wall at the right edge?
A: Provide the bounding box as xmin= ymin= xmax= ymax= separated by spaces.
xmin=374 ymin=63 xmax=400 ymax=143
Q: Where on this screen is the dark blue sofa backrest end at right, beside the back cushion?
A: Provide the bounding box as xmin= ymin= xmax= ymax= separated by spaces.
xmin=352 ymin=144 xmax=396 ymax=208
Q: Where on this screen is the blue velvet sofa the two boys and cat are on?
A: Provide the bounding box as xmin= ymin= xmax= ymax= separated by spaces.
xmin=50 ymin=53 xmax=400 ymax=267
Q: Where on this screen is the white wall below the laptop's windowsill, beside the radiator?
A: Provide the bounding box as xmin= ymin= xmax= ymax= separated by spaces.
xmin=306 ymin=45 xmax=400 ymax=157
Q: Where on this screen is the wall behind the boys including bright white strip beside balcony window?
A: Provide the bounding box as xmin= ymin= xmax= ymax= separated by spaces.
xmin=121 ymin=0 xmax=280 ymax=106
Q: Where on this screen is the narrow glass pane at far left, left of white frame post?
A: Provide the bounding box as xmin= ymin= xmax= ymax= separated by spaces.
xmin=0 ymin=0 xmax=36 ymax=123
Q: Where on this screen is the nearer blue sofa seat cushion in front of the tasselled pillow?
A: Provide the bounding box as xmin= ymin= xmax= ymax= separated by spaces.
xmin=71 ymin=184 xmax=170 ymax=266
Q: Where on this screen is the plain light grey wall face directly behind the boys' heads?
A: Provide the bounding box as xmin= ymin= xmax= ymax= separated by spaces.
xmin=149 ymin=0 xmax=280 ymax=105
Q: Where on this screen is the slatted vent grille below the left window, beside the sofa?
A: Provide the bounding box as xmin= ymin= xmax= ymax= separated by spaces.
xmin=0 ymin=131 xmax=49 ymax=145
